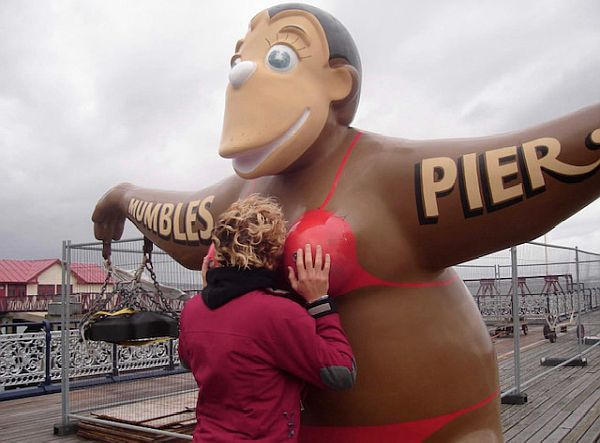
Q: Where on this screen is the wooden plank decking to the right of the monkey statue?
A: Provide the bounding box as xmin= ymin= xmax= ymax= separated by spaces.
xmin=498 ymin=312 xmax=600 ymax=443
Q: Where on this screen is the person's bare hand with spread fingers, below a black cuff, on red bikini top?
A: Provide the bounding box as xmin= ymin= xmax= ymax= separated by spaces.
xmin=288 ymin=244 xmax=331 ymax=303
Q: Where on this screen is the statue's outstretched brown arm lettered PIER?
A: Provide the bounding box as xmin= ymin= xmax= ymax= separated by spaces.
xmin=398 ymin=105 xmax=600 ymax=268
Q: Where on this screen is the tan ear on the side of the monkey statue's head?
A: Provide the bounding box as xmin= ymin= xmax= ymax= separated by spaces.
xmin=329 ymin=58 xmax=360 ymax=125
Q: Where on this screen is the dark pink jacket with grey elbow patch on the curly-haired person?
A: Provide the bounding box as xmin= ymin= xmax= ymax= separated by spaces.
xmin=179 ymin=290 xmax=356 ymax=443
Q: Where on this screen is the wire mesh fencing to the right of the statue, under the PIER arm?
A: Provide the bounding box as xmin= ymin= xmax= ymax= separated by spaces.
xmin=456 ymin=242 xmax=600 ymax=404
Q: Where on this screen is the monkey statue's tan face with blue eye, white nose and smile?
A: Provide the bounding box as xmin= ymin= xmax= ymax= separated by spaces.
xmin=219 ymin=10 xmax=352 ymax=178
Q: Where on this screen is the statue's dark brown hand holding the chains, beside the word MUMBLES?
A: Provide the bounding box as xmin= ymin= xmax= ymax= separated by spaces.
xmin=92 ymin=183 xmax=133 ymax=242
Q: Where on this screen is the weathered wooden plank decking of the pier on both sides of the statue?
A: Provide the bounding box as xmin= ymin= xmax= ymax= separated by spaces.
xmin=0 ymin=312 xmax=600 ymax=443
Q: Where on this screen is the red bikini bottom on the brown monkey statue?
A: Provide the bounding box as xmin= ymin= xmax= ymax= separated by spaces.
xmin=300 ymin=392 xmax=498 ymax=443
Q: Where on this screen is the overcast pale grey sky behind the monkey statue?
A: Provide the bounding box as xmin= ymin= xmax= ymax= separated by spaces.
xmin=0 ymin=0 xmax=600 ymax=258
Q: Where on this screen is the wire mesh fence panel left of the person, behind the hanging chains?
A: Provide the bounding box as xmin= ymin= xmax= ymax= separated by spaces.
xmin=63 ymin=239 xmax=201 ymax=439
